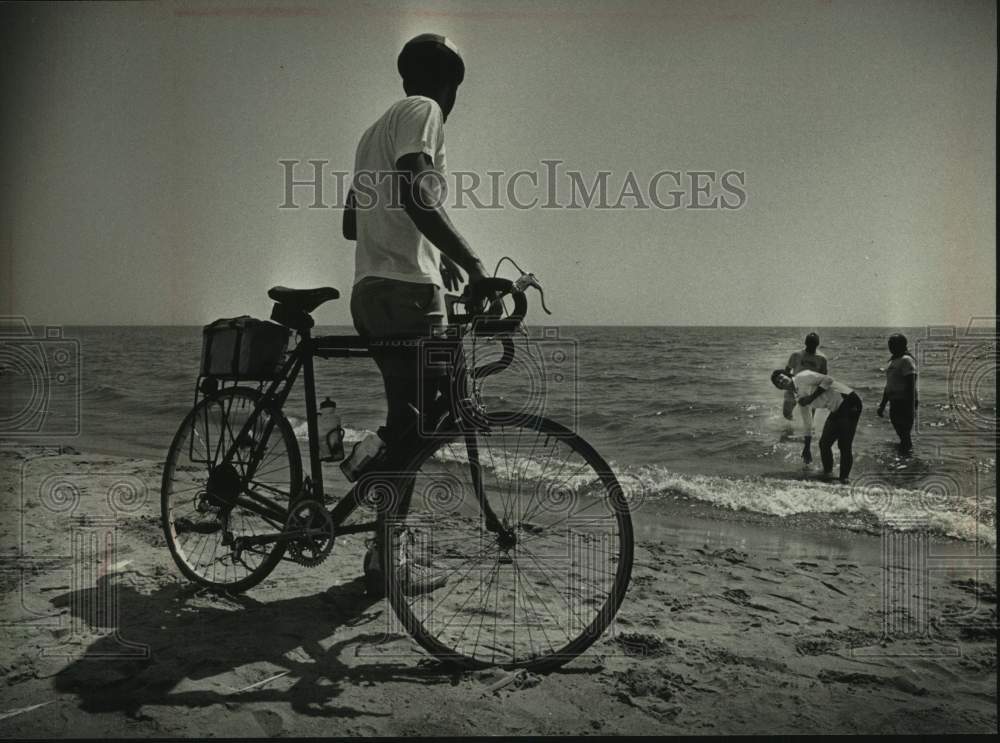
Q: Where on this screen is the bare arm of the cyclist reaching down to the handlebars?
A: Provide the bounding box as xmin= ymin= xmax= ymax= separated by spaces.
xmin=396 ymin=152 xmax=487 ymax=283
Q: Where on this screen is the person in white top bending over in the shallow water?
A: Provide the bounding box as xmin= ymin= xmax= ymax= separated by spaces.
xmin=771 ymin=369 xmax=861 ymax=484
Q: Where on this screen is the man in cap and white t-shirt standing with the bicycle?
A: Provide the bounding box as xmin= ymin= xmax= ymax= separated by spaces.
xmin=343 ymin=34 xmax=487 ymax=589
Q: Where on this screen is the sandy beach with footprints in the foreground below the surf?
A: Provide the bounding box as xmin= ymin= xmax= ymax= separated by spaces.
xmin=0 ymin=447 xmax=997 ymax=738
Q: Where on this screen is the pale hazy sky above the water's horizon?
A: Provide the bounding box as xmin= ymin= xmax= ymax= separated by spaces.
xmin=0 ymin=0 xmax=996 ymax=326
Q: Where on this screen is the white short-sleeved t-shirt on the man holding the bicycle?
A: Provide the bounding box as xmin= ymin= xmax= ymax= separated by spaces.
xmin=353 ymin=95 xmax=447 ymax=286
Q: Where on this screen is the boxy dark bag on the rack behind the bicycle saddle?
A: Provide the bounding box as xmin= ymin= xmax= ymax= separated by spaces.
xmin=201 ymin=315 xmax=289 ymax=380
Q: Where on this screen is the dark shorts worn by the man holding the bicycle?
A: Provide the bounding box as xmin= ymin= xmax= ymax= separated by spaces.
xmin=351 ymin=276 xmax=445 ymax=377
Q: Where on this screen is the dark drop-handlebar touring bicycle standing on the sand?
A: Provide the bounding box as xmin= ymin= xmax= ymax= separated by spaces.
xmin=161 ymin=261 xmax=633 ymax=670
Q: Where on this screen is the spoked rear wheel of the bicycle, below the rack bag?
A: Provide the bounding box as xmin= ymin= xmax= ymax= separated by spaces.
xmin=161 ymin=387 xmax=302 ymax=592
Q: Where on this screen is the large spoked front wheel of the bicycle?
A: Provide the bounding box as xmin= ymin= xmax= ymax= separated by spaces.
xmin=381 ymin=413 xmax=633 ymax=670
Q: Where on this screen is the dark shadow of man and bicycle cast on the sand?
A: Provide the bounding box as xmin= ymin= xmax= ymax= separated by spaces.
xmin=51 ymin=575 xmax=457 ymax=718
